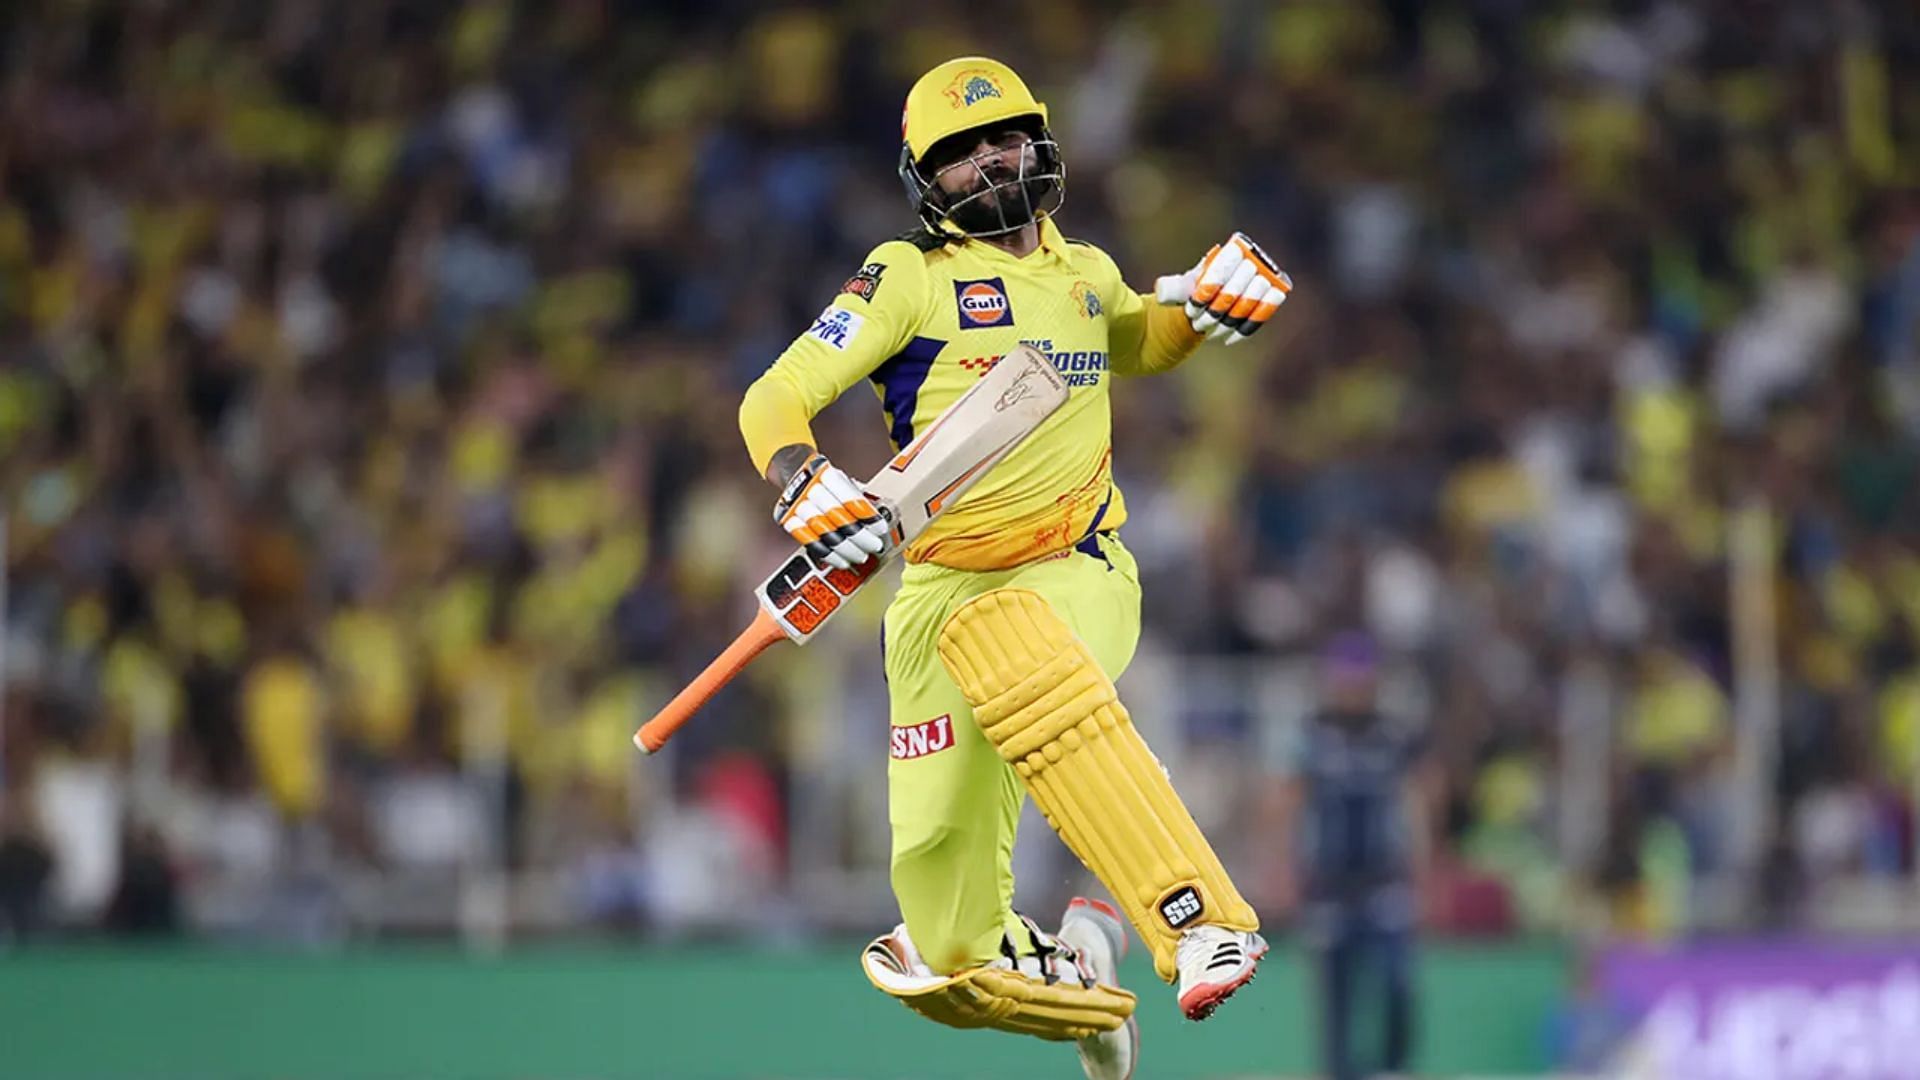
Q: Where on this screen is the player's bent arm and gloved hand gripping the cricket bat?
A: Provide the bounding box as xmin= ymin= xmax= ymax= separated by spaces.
xmin=739 ymin=242 xmax=925 ymax=567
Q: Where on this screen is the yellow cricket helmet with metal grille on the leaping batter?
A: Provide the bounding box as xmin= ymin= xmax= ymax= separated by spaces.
xmin=900 ymin=56 xmax=1068 ymax=236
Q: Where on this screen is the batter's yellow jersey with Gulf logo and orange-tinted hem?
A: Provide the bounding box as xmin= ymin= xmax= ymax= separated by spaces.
xmin=741 ymin=219 xmax=1202 ymax=571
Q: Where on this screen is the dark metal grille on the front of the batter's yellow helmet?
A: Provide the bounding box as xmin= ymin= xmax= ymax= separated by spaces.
xmin=900 ymin=123 xmax=1068 ymax=236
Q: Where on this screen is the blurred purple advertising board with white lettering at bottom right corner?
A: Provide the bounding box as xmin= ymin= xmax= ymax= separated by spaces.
xmin=1594 ymin=940 xmax=1920 ymax=1080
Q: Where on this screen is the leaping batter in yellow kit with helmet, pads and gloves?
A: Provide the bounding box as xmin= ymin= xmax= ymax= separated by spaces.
xmin=739 ymin=56 xmax=1292 ymax=1080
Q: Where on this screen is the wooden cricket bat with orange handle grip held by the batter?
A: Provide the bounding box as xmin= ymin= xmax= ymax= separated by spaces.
xmin=634 ymin=344 xmax=1068 ymax=753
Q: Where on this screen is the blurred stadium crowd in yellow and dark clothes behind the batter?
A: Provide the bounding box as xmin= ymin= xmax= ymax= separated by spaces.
xmin=0 ymin=0 xmax=1920 ymax=938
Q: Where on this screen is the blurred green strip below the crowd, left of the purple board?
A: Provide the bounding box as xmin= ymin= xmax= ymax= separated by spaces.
xmin=0 ymin=942 xmax=1567 ymax=1080
